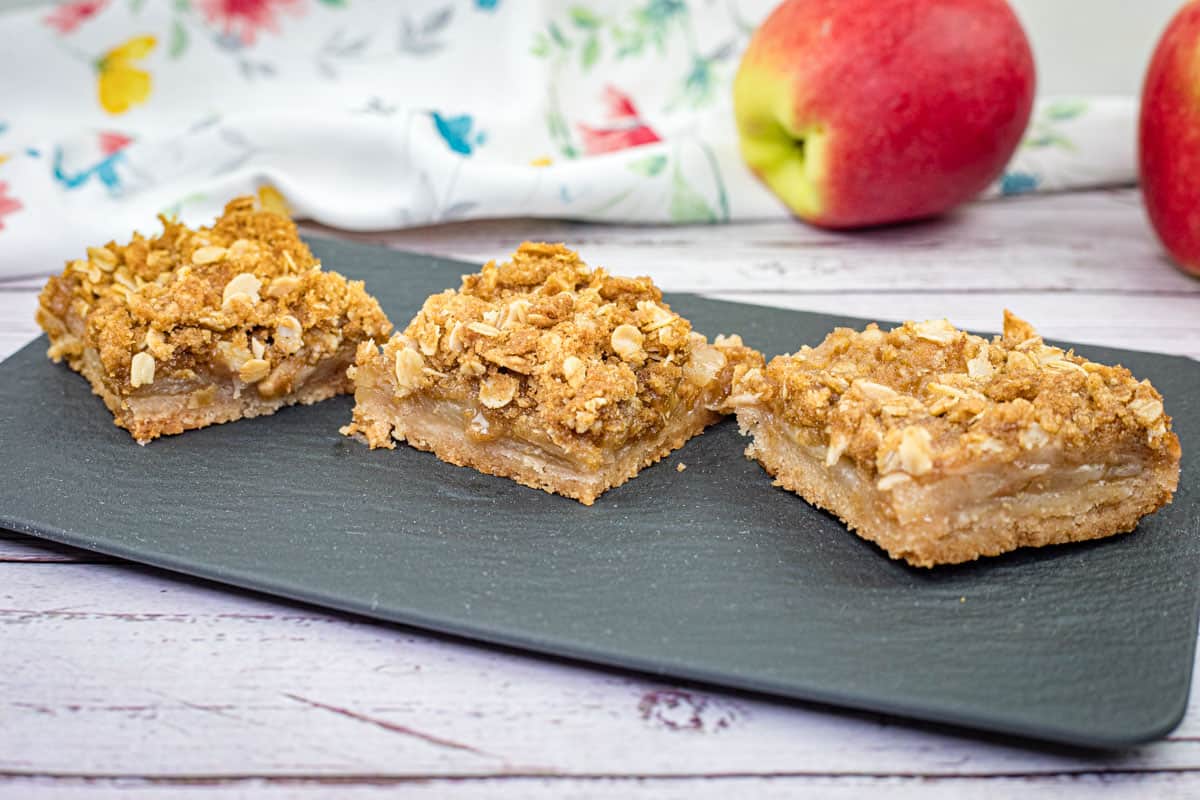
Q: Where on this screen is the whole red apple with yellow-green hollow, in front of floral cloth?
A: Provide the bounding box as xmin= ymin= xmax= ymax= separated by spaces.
xmin=733 ymin=0 xmax=1034 ymax=228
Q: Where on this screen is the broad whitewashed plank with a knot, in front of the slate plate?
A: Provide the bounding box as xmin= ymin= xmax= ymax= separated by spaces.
xmin=7 ymin=564 xmax=1200 ymax=777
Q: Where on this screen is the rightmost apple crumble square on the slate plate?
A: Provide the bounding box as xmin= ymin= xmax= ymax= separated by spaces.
xmin=730 ymin=312 xmax=1180 ymax=566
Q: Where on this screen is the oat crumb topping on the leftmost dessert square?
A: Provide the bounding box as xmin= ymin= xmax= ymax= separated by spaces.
xmin=40 ymin=197 xmax=391 ymax=393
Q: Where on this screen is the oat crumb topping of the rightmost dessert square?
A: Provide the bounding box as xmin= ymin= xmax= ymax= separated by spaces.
xmin=730 ymin=311 xmax=1180 ymax=489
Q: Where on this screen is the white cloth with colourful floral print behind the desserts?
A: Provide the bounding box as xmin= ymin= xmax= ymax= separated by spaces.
xmin=0 ymin=0 xmax=1135 ymax=277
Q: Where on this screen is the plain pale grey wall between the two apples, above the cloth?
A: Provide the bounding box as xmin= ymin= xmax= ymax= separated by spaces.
xmin=0 ymin=0 xmax=1183 ymax=95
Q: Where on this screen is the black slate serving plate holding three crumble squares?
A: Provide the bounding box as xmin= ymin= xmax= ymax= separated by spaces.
xmin=0 ymin=235 xmax=1200 ymax=747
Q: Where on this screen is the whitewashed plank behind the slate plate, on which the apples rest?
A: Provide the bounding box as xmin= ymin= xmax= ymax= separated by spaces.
xmin=308 ymin=190 xmax=1200 ymax=295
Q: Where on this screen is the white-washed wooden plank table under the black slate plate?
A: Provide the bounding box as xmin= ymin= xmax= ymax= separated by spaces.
xmin=0 ymin=190 xmax=1200 ymax=799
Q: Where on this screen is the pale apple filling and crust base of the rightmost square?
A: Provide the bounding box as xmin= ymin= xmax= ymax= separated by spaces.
xmin=738 ymin=409 xmax=1177 ymax=566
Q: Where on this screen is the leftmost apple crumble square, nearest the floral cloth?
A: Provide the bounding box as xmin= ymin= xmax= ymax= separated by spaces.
xmin=37 ymin=198 xmax=391 ymax=444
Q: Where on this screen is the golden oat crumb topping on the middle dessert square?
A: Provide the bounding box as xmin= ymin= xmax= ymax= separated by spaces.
xmin=374 ymin=242 xmax=762 ymax=446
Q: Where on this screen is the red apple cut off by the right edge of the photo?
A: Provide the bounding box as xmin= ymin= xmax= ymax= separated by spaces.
xmin=1138 ymin=2 xmax=1200 ymax=275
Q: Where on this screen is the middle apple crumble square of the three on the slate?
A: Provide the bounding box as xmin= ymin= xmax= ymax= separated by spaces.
xmin=343 ymin=242 xmax=763 ymax=505
